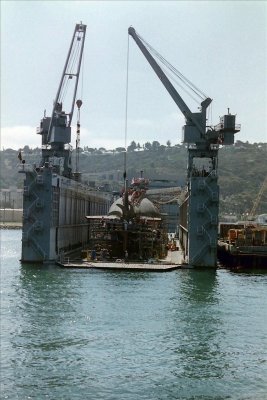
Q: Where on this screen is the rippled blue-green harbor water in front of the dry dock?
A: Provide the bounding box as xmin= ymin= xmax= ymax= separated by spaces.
xmin=1 ymin=230 xmax=267 ymax=400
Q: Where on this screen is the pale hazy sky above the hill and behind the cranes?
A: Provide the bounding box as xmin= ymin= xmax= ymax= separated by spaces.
xmin=1 ymin=0 xmax=267 ymax=149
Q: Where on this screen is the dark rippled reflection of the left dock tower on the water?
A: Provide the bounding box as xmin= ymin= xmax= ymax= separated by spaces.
xmin=10 ymin=264 xmax=90 ymax=396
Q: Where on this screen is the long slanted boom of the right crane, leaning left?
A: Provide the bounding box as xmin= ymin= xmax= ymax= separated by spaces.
xmin=128 ymin=26 xmax=212 ymax=135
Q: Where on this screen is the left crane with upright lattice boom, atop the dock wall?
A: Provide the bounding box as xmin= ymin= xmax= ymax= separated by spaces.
xmin=37 ymin=23 xmax=86 ymax=177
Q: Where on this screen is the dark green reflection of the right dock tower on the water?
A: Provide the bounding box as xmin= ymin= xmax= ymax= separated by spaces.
xmin=165 ymin=270 xmax=230 ymax=399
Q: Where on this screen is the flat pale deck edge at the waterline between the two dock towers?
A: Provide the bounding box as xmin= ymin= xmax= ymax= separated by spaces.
xmin=57 ymin=251 xmax=184 ymax=272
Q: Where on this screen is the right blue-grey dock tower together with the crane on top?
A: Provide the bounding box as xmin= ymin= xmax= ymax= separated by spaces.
xmin=128 ymin=27 xmax=240 ymax=267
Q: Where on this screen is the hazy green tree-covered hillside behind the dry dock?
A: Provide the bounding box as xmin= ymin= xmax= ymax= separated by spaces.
xmin=0 ymin=141 xmax=267 ymax=214
